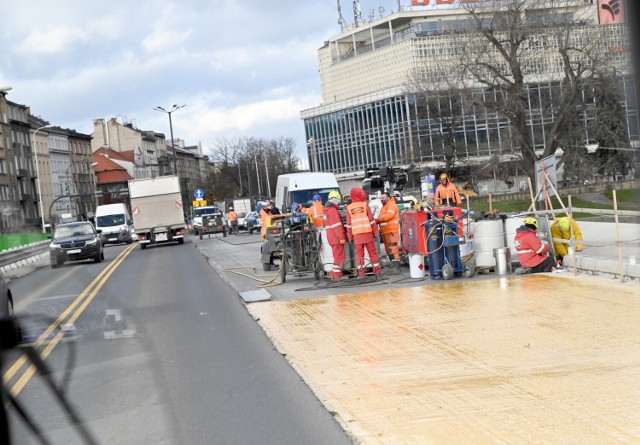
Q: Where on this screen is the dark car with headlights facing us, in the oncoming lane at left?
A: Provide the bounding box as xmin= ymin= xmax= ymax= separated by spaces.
xmin=49 ymin=221 xmax=104 ymax=269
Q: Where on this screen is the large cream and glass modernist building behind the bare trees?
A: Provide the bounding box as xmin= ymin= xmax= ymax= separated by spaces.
xmin=301 ymin=0 xmax=640 ymax=180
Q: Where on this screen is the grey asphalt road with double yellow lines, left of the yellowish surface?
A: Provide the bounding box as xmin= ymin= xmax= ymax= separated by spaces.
xmin=3 ymin=241 xmax=351 ymax=444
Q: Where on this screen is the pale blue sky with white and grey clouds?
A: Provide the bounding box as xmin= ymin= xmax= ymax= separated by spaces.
xmin=0 ymin=0 xmax=418 ymax=158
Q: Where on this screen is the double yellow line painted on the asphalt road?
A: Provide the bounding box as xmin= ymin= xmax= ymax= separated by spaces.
xmin=2 ymin=244 xmax=136 ymax=397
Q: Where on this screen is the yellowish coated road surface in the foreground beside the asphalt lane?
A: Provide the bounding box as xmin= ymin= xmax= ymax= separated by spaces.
xmin=249 ymin=274 xmax=640 ymax=445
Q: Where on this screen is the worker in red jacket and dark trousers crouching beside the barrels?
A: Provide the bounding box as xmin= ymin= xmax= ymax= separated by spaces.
xmin=514 ymin=217 xmax=556 ymax=275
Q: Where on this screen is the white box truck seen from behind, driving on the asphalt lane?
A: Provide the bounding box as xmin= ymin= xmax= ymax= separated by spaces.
xmin=129 ymin=175 xmax=185 ymax=249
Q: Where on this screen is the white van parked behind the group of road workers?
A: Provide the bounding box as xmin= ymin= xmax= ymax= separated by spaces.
xmin=275 ymin=172 xmax=340 ymax=213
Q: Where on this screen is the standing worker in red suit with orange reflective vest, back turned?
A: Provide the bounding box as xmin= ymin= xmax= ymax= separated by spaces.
xmin=347 ymin=187 xmax=380 ymax=279
